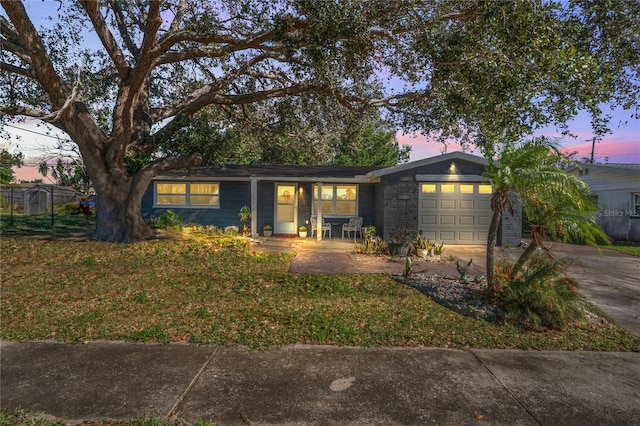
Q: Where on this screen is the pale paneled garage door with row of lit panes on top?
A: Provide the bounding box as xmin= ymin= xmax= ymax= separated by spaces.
xmin=418 ymin=182 xmax=493 ymax=244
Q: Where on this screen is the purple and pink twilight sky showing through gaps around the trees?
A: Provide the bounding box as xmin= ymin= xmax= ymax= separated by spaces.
xmin=0 ymin=0 xmax=640 ymax=181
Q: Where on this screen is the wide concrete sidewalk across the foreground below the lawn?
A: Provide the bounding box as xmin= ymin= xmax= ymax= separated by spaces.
xmin=0 ymin=342 xmax=640 ymax=426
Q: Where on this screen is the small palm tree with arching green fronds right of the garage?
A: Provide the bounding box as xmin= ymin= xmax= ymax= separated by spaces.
xmin=485 ymin=137 xmax=606 ymax=285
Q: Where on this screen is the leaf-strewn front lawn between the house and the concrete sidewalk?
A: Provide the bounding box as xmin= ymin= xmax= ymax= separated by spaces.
xmin=0 ymin=228 xmax=640 ymax=351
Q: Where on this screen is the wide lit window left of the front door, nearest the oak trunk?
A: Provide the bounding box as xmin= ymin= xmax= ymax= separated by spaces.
xmin=155 ymin=182 xmax=220 ymax=208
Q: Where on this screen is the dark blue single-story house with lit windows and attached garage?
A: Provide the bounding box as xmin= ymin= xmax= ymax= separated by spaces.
xmin=142 ymin=152 xmax=521 ymax=245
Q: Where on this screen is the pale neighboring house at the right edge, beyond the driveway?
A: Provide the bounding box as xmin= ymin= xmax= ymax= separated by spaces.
xmin=568 ymin=163 xmax=640 ymax=242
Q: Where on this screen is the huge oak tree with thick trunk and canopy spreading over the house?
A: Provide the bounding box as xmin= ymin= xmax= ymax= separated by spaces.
xmin=0 ymin=0 xmax=640 ymax=241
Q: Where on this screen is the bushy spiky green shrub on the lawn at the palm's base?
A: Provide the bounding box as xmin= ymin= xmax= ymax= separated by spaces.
xmin=486 ymin=255 xmax=583 ymax=329
